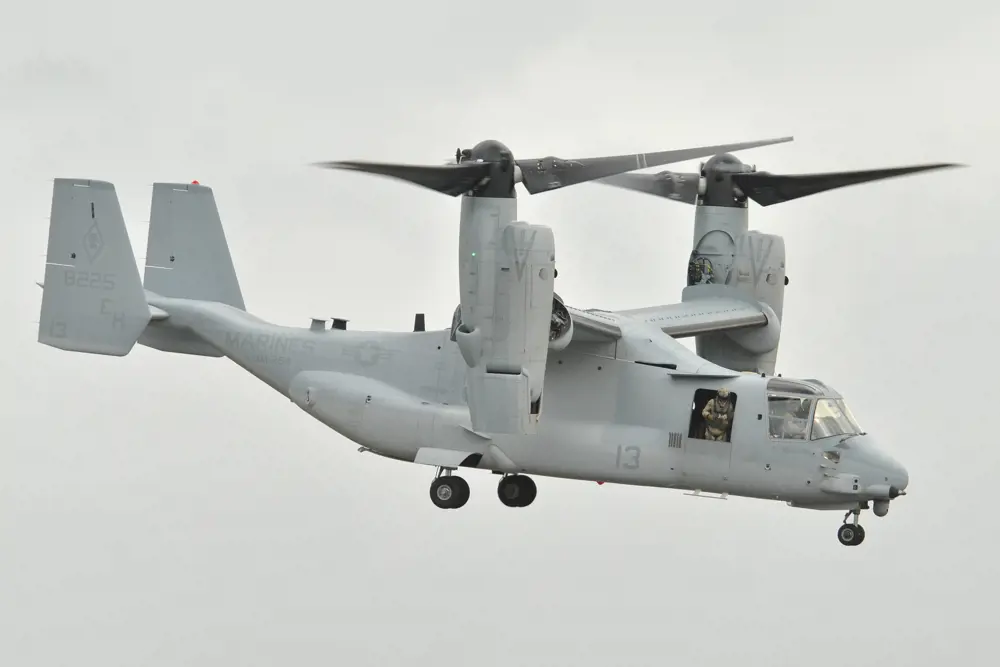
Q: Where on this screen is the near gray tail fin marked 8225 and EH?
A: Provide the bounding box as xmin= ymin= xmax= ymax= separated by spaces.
xmin=38 ymin=178 xmax=151 ymax=357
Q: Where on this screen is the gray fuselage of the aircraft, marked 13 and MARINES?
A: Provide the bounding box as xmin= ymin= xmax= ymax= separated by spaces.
xmin=147 ymin=293 xmax=908 ymax=509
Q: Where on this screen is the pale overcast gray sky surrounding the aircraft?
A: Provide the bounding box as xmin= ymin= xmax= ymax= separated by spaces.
xmin=0 ymin=0 xmax=1000 ymax=667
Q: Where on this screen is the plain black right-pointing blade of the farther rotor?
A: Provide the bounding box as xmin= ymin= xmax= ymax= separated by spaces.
xmin=732 ymin=162 xmax=964 ymax=206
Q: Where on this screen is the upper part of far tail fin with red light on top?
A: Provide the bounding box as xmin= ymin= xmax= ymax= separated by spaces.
xmin=143 ymin=183 xmax=246 ymax=310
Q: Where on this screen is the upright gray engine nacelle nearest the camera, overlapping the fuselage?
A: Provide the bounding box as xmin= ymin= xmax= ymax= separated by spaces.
xmin=454 ymin=197 xmax=556 ymax=434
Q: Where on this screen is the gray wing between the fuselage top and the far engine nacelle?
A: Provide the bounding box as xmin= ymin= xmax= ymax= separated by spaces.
xmin=612 ymin=297 xmax=767 ymax=338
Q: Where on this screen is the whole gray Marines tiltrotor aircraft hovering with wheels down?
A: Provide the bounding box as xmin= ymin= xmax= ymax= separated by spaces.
xmin=38 ymin=137 xmax=950 ymax=546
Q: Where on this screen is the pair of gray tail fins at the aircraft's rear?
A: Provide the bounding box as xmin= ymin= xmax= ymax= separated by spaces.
xmin=38 ymin=178 xmax=244 ymax=357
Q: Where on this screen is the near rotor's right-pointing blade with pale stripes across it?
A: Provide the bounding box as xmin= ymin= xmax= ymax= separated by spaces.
xmin=517 ymin=137 xmax=792 ymax=194
